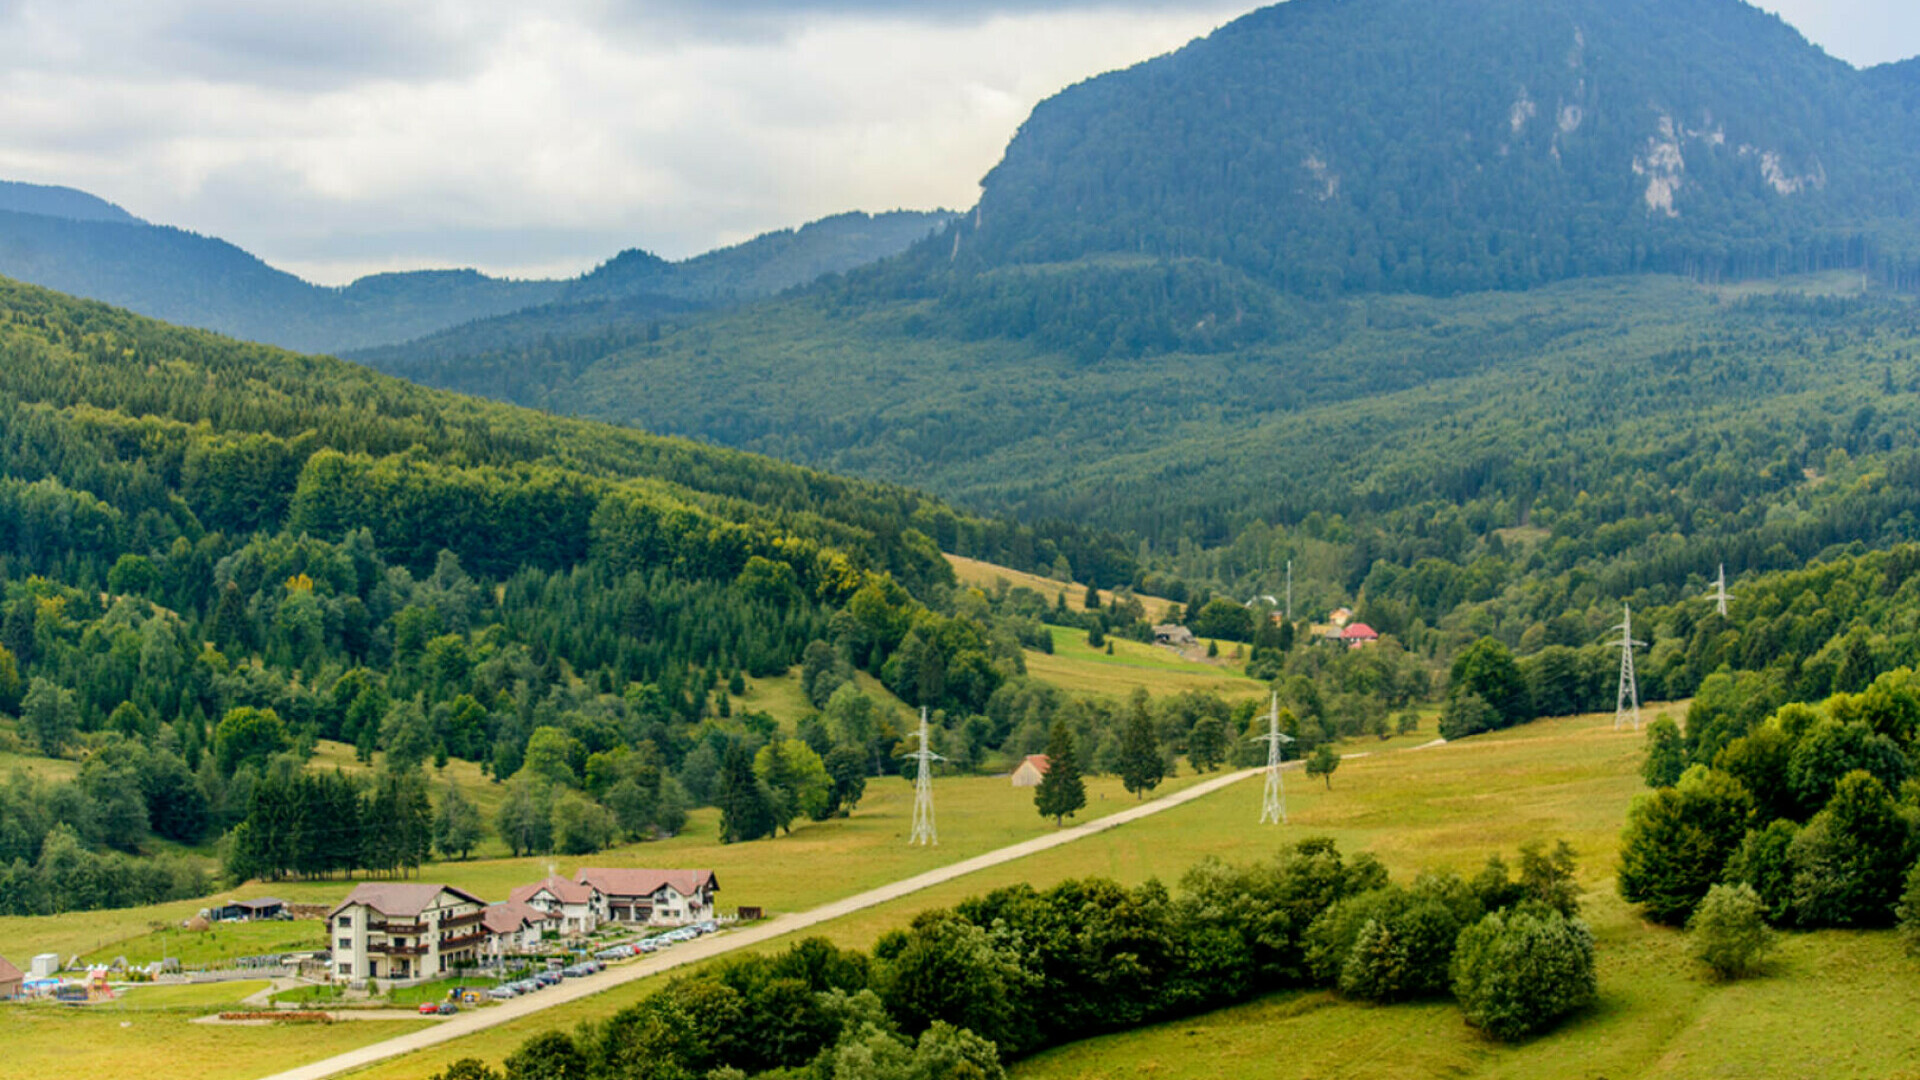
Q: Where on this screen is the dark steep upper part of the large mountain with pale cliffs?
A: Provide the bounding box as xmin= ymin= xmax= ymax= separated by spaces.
xmin=927 ymin=0 xmax=1920 ymax=294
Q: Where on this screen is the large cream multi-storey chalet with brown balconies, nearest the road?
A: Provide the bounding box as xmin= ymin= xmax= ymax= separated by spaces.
xmin=326 ymin=882 xmax=488 ymax=982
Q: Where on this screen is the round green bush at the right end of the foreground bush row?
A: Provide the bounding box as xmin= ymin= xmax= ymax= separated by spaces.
xmin=1453 ymin=905 xmax=1599 ymax=1042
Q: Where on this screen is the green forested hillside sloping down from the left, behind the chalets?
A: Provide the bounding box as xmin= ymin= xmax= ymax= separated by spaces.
xmin=0 ymin=281 xmax=1144 ymax=913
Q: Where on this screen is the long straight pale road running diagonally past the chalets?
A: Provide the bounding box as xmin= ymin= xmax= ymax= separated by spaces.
xmin=265 ymin=763 xmax=1274 ymax=1080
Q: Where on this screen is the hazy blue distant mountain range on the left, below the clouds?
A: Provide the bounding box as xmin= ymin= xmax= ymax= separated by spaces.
xmin=0 ymin=184 xmax=945 ymax=352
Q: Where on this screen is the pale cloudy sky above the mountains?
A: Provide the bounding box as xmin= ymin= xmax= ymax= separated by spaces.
xmin=0 ymin=0 xmax=1920 ymax=282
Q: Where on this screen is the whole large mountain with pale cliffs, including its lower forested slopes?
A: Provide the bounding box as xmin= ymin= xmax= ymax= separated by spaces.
xmin=353 ymin=0 xmax=1920 ymax=621
